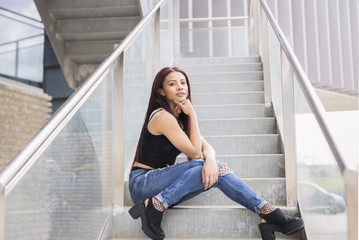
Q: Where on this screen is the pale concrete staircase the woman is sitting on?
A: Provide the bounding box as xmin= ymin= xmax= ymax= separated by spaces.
xmin=113 ymin=56 xmax=300 ymax=239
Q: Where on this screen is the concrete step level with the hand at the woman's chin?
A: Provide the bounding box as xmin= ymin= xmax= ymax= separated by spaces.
xmin=194 ymin=104 xmax=273 ymax=119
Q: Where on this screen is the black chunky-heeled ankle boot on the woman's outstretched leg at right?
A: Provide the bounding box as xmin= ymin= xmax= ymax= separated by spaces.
xmin=259 ymin=208 xmax=304 ymax=240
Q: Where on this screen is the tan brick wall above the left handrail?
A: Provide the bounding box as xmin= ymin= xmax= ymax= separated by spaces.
xmin=0 ymin=77 xmax=51 ymax=171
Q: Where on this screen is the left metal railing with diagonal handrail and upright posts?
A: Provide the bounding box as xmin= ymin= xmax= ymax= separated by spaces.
xmin=0 ymin=0 xmax=172 ymax=240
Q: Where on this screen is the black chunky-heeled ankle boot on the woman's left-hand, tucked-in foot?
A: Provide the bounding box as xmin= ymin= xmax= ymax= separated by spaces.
xmin=128 ymin=198 xmax=165 ymax=240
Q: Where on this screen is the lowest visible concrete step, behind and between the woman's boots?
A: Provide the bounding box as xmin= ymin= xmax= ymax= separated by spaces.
xmin=113 ymin=204 xmax=299 ymax=239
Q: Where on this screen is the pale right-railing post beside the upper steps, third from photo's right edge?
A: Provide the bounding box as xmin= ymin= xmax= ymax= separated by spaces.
xmin=259 ymin=0 xmax=272 ymax=105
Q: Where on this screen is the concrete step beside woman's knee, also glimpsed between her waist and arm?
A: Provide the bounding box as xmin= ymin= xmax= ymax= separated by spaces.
xmin=176 ymin=154 xmax=285 ymax=178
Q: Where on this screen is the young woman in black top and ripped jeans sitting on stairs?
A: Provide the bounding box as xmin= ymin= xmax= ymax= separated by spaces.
xmin=129 ymin=67 xmax=304 ymax=239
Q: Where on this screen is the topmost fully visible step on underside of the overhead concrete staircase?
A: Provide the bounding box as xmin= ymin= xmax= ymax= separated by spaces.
xmin=49 ymin=6 xmax=141 ymax=19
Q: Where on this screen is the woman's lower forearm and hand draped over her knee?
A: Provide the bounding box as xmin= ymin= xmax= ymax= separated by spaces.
xmin=201 ymin=137 xmax=218 ymax=190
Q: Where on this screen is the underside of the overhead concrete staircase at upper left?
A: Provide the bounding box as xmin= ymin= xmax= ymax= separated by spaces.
xmin=34 ymin=0 xmax=141 ymax=88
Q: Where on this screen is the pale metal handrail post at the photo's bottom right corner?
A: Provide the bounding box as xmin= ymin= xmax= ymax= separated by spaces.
xmin=343 ymin=169 xmax=359 ymax=240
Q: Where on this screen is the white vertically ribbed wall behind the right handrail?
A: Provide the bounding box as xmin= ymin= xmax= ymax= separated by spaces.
xmin=268 ymin=0 xmax=359 ymax=96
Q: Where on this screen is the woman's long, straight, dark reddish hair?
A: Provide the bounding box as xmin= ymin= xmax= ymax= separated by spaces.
xmin=133 ymin=67 xmax=192 ymax=166
